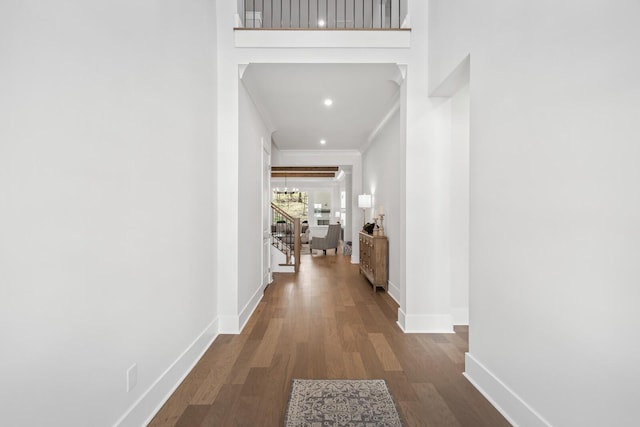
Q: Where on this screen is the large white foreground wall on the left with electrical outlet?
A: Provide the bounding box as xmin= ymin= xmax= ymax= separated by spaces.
xmin=0 ymin=0 xmax=217 ymax=426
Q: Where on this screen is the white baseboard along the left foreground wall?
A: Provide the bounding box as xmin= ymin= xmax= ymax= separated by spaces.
xmin=115 ymin=319 xmax=218 ymax=427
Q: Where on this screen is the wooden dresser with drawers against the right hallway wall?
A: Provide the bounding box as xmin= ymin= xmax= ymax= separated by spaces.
xmin=358 ymin=231 xmax=389 ymax=292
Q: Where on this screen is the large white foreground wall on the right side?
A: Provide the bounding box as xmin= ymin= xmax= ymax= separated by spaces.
xmin=430 ymin=0 xmax=640 ymax=426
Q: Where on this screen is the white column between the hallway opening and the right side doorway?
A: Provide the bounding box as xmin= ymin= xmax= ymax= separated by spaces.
xmin=398 ymin=63 xmax=453 ymax=333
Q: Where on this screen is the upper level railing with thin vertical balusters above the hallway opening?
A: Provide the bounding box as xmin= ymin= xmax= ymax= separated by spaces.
xmin=238 ymin=0 xmax=407 ymax=30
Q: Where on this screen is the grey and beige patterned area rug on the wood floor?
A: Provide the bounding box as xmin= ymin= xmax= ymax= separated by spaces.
xmin=285 ymin=379 xmax=402 ymax=427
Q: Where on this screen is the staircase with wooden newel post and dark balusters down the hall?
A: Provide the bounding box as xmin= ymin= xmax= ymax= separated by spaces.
xmin=271 ymin=203 xmax=301 ymax=273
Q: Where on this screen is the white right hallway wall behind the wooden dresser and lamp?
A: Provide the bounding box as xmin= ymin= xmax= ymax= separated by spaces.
xmin=360 ymin=110 xmax=402 ymax=300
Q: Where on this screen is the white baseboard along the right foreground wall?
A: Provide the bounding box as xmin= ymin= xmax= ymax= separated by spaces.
xmin=463 ymin=353 xmax=551 ymax=427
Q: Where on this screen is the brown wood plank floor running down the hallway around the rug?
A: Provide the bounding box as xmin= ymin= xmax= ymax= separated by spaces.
xmin=150 ymin=251 xmax=509 ymax=427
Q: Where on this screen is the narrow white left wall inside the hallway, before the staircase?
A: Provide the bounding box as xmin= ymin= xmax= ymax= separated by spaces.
xmin=238 ymin=79 xmax=271 ymax=329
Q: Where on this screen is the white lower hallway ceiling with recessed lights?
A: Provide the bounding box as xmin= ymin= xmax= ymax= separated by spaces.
xmin=242 ymin=64 xmax=400 ymax=150
